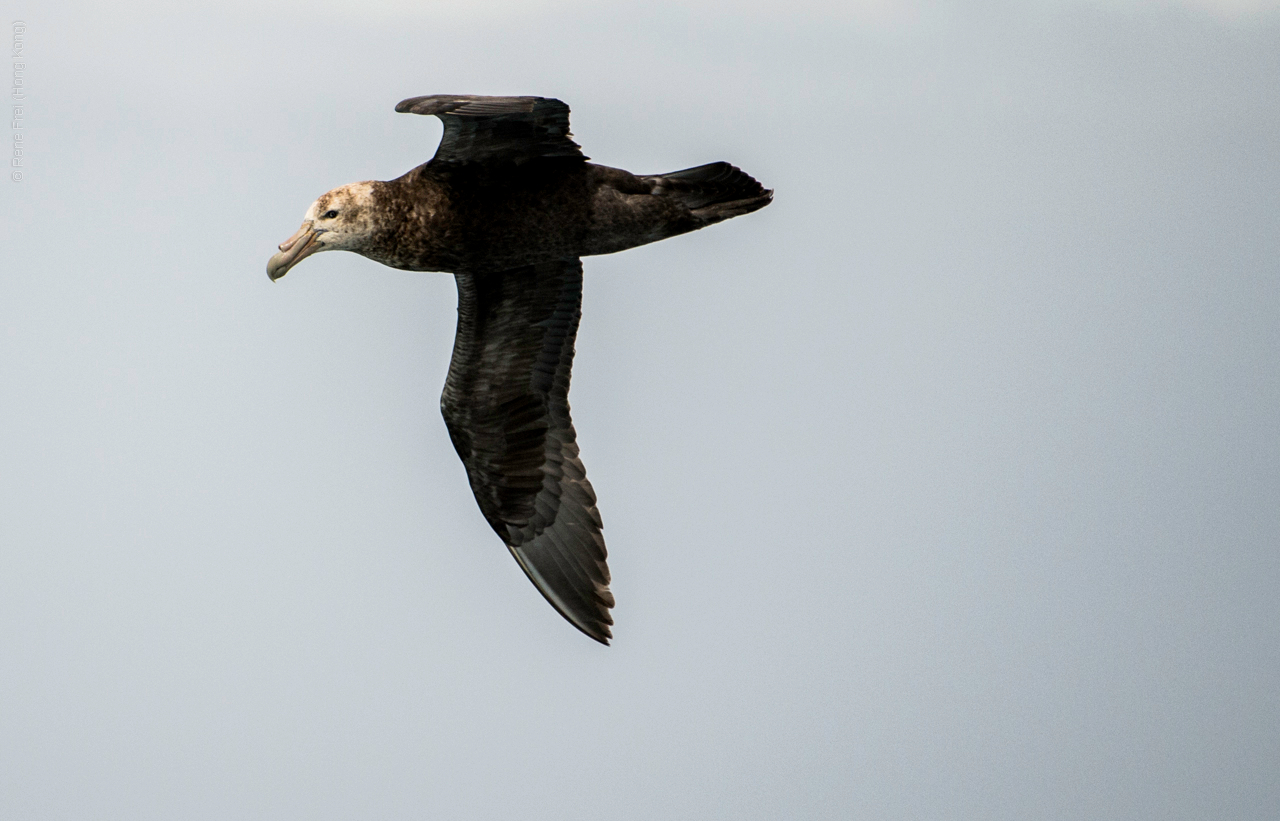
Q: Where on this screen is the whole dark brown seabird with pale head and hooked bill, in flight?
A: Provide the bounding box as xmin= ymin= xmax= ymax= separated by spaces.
xmin=266 ymin=95 xmax=773 ymax=644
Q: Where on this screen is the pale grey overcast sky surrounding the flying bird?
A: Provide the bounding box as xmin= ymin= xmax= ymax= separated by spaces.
xmin=0 ymin=0 xmax=1280 ymax=821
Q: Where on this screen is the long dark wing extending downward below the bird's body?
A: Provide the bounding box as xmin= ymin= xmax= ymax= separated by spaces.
xmin=440 ymin=259 xmax=613 ymax=644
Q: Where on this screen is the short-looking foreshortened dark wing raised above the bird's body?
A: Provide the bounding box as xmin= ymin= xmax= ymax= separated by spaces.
xmin=396 ymin=93 xmax=586 ymax=165
